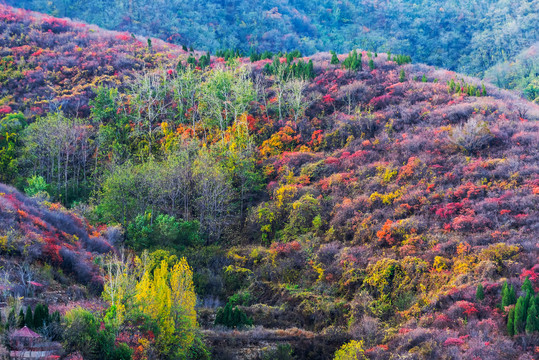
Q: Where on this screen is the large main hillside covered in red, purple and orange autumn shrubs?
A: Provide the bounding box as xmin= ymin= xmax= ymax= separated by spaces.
xmin=0 ymin=6 xmax=539 ymax=359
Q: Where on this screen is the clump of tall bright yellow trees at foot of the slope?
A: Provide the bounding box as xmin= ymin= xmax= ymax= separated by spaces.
xmin=103 ymin=252 xmax=198 ymax=359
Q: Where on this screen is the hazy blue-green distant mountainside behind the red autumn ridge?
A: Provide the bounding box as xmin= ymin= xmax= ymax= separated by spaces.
xmin=6 ymin=0 xmax=539 ymax=79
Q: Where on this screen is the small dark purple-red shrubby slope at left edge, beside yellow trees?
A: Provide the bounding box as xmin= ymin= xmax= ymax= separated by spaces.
xmin=0 ymin=180 xmax=116 ymax=300
